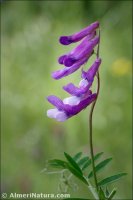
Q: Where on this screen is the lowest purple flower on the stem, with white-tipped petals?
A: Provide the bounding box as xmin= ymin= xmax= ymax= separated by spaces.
xmin=47 ymin=94 xmax=97 ymax=122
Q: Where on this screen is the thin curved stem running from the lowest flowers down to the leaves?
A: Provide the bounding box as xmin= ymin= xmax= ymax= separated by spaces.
xmin=89 ymin=72 xmax=100 ymax=195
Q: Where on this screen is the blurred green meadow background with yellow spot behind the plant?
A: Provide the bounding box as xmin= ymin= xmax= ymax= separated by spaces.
xmin=1 ymin=0 xmax=132 ymax=200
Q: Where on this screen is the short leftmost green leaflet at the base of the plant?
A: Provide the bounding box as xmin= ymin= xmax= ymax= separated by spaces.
xmin=47 ymin=159 xmax=67 ymax=169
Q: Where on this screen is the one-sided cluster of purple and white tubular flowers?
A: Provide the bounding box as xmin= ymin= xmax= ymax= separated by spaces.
xmin=47 ymin=22 xmax=101 ymax=121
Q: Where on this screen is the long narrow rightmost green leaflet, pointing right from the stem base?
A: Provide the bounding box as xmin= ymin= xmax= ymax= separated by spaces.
xmin=98 ymin=173 xmax=127 ymax=186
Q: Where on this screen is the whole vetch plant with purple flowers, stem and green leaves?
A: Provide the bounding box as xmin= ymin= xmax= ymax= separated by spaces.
xmin=46 ymin=22 xmax=126 ymax=200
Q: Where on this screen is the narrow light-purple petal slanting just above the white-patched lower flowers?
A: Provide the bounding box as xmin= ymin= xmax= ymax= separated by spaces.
xmin=52 ymin=57 xmax=88 ymax=79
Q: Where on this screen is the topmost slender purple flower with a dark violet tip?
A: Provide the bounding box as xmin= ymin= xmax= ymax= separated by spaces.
xmin=59 ymin=22 xmax=99 ymax=45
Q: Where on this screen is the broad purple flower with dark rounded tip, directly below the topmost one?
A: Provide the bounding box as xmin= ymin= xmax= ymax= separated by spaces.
xmin=63 ymin=36 xmax=99 ymax=67
